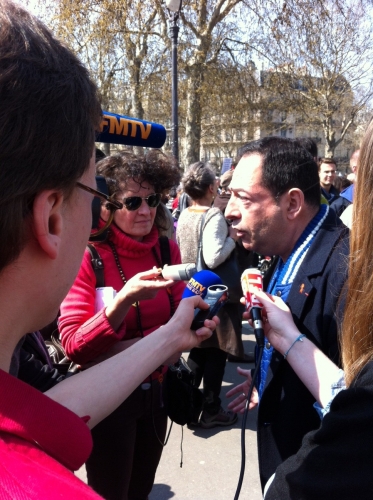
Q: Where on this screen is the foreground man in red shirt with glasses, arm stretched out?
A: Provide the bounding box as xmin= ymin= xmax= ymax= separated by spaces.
xmin=0 ymin=0 xmax=218 ymax=500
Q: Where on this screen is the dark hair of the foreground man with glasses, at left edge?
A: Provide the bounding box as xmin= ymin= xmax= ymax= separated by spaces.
xmin=0 ymin=0 xmax=101 ymax=269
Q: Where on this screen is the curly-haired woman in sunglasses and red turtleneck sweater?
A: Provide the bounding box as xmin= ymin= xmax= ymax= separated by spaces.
xmin=59 ymin=150 xmax=185 ymax=500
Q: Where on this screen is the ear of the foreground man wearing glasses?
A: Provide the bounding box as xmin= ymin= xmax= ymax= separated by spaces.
xmin=33 ymin=190 xmax=64 ymax=259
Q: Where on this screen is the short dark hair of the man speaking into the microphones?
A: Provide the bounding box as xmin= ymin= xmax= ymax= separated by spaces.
xmin=238 ymin=137 xmax=320 ymax=206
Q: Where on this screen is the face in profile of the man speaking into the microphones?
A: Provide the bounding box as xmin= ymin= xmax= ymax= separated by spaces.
xmin=225 ymin=154 xmax=292 ymax=256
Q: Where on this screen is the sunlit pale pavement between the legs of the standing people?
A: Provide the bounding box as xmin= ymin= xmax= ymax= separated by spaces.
xmin=78 ymin=324 xmax=262 ymax=500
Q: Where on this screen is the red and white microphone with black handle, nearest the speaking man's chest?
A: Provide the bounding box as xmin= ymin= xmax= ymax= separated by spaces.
xmin=241 ymin=268 xmax=264 ymax=347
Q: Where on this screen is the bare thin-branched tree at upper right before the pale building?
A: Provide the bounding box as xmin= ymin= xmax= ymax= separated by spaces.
xmin=250 ymin=0 xmax=373 ymax=157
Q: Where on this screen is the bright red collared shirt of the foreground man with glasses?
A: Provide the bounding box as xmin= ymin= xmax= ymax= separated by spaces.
xmin=0 ymin=370 xmax=101 ymax=500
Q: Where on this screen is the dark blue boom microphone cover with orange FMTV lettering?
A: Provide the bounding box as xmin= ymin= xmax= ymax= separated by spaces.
xmin=96 ymin=111 xmax=166 ymax=148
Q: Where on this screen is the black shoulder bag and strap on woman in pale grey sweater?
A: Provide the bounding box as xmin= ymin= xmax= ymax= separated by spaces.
xmin=196 ymin=210 xmax=243 ymax=302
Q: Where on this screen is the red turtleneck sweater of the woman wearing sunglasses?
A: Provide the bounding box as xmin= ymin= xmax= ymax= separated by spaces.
xmin=59 ymin=224 xmax=185 ymax=364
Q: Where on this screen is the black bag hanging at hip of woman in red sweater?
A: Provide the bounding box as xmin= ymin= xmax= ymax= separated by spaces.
xmin=164 ymin=357 xmax=203 ymax=425
